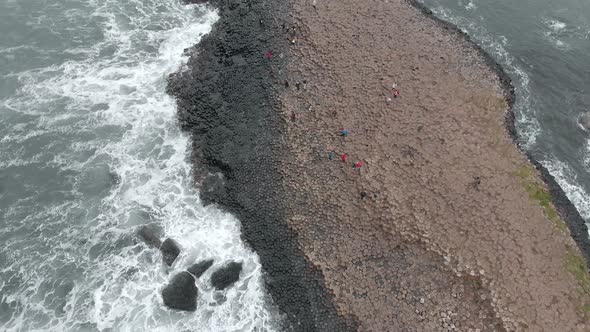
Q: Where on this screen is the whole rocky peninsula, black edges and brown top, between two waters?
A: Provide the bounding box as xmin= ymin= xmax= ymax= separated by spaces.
xmin=169 ymin=0 xmax=590 ymax=331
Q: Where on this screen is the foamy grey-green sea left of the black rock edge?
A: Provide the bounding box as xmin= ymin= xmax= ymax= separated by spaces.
xmin=0 ymin=0 xmax=275 ymax=331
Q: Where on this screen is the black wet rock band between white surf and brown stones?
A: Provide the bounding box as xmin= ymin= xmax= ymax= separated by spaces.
xmin=168 ymin=0 xmax=355 ymax=332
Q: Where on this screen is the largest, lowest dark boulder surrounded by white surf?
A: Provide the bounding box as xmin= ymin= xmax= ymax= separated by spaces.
xmin=162 ymin=271 xmax=199 ymax=311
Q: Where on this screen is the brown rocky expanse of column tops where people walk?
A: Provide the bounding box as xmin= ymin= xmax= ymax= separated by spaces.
xmin=280 ymin=0 xmax=590 ymax=331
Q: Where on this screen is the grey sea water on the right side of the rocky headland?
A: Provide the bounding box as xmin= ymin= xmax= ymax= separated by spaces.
xmin=423 ymin=0 xmax=590 ymax=232
